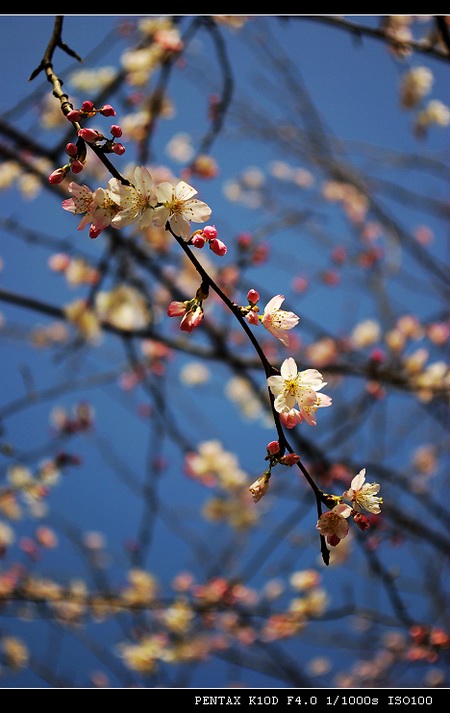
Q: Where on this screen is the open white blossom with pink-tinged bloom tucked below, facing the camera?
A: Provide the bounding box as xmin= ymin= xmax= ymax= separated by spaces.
xmin=267 ymin=357 xmax=331 ymax=426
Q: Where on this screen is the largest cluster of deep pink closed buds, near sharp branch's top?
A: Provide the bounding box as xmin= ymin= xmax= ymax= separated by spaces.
xmin=48 ymin=101 xmax=125 ymax=184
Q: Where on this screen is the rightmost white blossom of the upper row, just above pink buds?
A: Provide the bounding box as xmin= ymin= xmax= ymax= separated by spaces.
xmin=154 ymin=181 xmax=212 ymax=240
